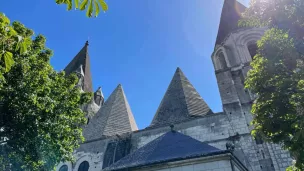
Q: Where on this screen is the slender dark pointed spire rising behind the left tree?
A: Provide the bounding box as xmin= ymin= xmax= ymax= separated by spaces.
xmin=64 ymin=41 xmax=93 ymax=92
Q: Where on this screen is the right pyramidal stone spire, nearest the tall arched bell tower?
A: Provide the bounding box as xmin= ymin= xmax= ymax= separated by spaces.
xmin=150 ymin=68 xmax=212 ymax=127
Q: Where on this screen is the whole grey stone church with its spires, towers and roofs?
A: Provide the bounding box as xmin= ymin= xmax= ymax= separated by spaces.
xmin=56 ymin=0 xmax=292 ymax=171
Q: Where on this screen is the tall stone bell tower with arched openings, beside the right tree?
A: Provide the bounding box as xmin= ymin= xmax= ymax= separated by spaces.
xmin=212 ymin=0 xmax=265 ymax=133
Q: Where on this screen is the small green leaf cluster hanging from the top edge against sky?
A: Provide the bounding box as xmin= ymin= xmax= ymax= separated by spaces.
xmin=56 ymin=0 xmax=108 ymax=17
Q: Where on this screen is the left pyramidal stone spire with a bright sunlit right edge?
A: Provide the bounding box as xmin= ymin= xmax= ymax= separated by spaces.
xmin=83 ymin=84 xmax=138 ymax=140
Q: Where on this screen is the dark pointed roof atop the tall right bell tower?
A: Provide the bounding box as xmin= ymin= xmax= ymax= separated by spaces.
xmin=215 ymin=0 xmax=246 ymax=45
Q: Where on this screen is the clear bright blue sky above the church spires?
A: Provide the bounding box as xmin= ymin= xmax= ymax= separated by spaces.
xmin=0 ymin=0 xmax=249 ymax=129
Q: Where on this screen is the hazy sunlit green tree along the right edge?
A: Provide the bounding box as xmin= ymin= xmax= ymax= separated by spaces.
xmin=239 ymin=0 xmax=304 ymax=170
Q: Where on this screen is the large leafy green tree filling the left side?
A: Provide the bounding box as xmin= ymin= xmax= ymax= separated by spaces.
xmin=0 ymin=14 xmax=92 ymax=171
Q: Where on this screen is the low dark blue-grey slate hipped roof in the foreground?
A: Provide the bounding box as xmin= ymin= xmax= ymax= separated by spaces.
xmin=105 ymin=131 xmax=227 ymax=171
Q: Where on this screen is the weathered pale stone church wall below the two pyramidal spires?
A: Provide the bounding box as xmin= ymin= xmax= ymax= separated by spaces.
xmin=57 ymin=111 xmax=291 ymax=171
